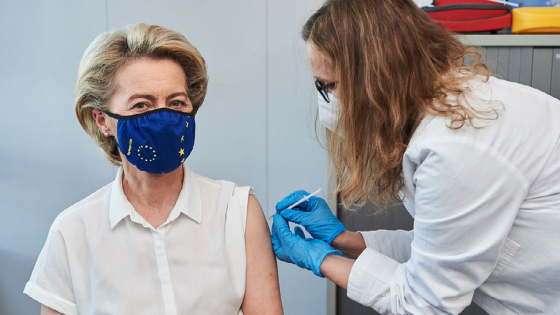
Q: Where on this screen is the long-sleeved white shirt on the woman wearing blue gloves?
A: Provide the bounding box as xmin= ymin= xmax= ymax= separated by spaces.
xmin=348 ymin=78 xmax=560 ymax=315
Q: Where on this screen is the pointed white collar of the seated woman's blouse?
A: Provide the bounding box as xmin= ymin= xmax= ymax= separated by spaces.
xmin=109 ymin=164 xmax=202 ymax=229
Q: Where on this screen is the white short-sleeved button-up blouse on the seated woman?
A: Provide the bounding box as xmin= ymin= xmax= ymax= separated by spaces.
xmin=24 ymin=165 xmax=254 ymax=315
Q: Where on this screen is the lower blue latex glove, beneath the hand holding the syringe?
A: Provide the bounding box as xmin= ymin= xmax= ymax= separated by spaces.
xmin=272 ymin=214 xmax=342 ymax=278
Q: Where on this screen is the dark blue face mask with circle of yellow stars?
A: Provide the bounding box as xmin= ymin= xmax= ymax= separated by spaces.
xmin=105 ymin=108 xmax=195 ymax=174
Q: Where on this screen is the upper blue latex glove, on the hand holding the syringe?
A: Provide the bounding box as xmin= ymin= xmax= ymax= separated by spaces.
xmin=276 ymin=190 xmax=346 ymax=245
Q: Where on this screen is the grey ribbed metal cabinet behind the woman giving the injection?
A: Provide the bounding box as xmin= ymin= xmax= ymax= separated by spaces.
xmin=331 ymin=35 xmax=560 ymax=315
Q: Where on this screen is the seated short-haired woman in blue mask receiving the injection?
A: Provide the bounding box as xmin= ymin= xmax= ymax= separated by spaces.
xmin=24 ymin=24 xmax=283 ymax=315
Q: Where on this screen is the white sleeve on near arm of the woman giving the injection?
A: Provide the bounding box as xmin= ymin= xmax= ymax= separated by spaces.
xmin=348 ymin=137 xmax=529 ymax=314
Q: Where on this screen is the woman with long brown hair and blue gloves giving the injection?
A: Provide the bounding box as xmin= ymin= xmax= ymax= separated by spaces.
xmin=272 ymin=0 xmax=560 ymax=315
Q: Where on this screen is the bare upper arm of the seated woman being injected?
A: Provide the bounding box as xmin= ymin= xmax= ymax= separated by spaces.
xmin=241 ymin=195 xmax=283 ymax=315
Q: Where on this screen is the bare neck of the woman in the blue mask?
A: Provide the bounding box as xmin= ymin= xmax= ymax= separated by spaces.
xmin=122 ymin=158 xmax=184 ymax=228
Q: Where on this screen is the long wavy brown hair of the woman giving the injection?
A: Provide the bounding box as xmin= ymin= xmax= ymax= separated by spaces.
xmin=302 ymin=0 xmax=497 ymax=209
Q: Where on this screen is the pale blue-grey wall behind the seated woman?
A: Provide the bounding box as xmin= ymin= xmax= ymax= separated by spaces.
xmin=0 ymin=0 xmax=326 ymax=315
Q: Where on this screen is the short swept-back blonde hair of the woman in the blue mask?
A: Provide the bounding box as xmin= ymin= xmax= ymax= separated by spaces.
xmin=75 ymin=23 xmax=208 ymax=166
